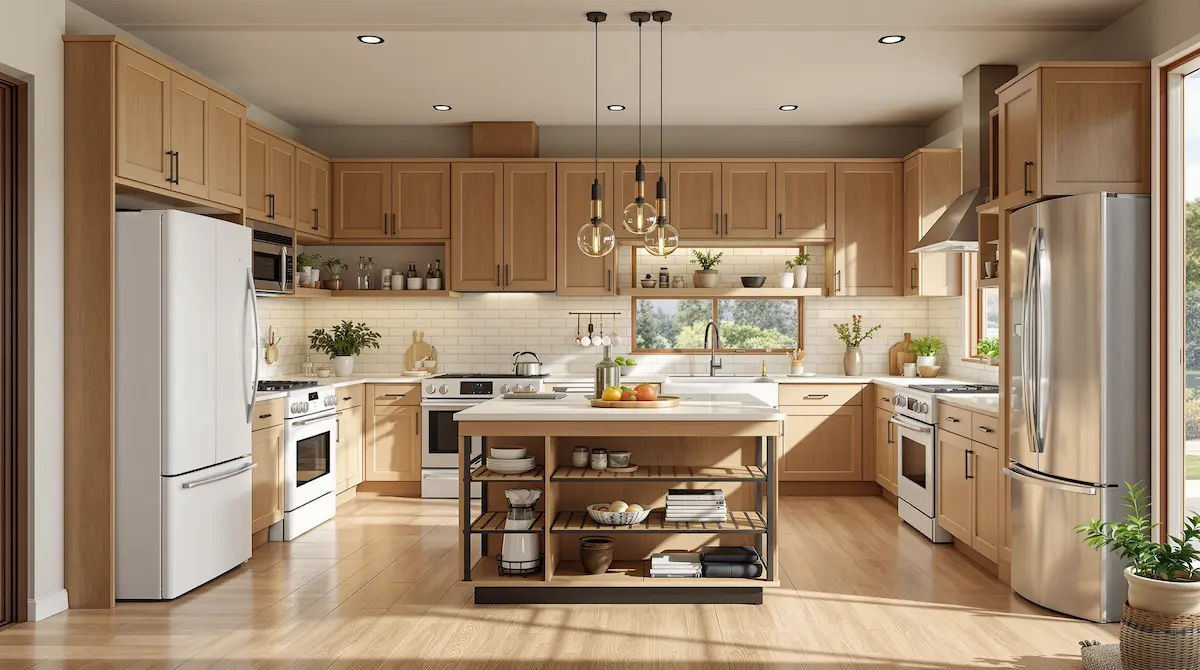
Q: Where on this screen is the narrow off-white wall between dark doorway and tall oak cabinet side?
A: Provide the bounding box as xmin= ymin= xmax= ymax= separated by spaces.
xmin=0 ymin=0 xmax=67 ymax=621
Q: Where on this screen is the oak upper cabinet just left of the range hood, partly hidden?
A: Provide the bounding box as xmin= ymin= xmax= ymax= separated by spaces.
xmin=904 ymin=149 xmax=962 ymax=297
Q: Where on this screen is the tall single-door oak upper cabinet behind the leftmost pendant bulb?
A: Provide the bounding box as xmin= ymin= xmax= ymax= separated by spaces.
xmin=557 ymin=163 xmax=620 ymax=295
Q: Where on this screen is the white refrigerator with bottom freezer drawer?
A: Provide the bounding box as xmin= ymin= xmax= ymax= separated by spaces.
xmin=114 ymin=210 xmax=258 ymax=600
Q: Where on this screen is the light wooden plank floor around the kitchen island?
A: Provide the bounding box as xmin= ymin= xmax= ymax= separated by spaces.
xmin=0 ymin=497 xmax=1117 ymax=670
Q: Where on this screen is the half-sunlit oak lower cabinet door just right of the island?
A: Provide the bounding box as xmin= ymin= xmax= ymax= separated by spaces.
xmin=779 ymin=405 xmax=863 ymax=481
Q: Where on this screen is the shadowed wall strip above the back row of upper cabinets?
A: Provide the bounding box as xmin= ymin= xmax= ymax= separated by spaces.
xmin=300 ymin=126 xmax=925 ymax=158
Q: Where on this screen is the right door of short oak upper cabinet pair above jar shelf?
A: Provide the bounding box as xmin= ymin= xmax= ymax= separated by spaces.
xmin=391 ymin=163 xmax=450 ymax=240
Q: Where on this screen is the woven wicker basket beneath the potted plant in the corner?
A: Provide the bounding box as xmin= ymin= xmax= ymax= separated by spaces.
xmin=1121 ymin=603 xmax=1200 ymax=670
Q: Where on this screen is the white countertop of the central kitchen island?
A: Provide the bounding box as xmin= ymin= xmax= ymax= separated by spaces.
xmin=454 ymin=394 xmax=786 ymax=421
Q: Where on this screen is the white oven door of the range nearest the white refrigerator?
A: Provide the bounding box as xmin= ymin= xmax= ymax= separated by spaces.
xmin=283 ymin=411 xmax=337 ymax=512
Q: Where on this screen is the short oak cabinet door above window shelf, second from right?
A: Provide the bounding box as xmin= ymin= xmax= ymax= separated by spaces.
xmin=721 ymin=163 xmax=778 ymax=239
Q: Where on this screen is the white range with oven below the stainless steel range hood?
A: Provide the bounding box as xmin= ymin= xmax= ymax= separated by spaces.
xmin=892 ymin=384 xmax=1000 ymax=543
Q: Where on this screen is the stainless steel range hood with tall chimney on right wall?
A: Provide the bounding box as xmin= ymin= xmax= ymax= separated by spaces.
xmin=911 ymin=65 xmax=1016 ymax=253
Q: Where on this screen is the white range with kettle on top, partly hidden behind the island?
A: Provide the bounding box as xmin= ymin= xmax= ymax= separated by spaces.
xmin=421 ymin=373 xmax=545 ymax=498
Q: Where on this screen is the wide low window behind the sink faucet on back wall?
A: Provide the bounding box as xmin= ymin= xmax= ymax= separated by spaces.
xmin=634 ymin=299 xmax=804 ymax=353
